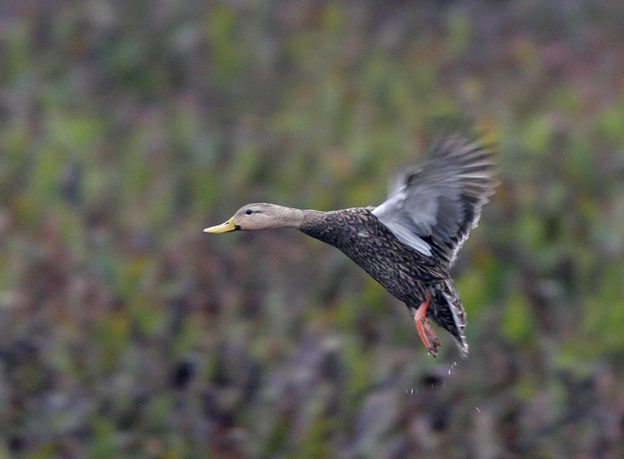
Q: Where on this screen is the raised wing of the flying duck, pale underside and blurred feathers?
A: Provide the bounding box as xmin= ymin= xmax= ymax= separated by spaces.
xmin=373 ymin=120 xmax=498 ymax=267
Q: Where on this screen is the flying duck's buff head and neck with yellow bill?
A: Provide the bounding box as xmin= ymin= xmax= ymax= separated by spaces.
xmin=204 ymin=202 xmax=304 ymax=233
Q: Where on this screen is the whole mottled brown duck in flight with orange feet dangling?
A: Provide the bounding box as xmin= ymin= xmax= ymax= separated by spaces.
xmin=205 ymin=124 xmax=497 ymax=356
